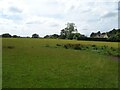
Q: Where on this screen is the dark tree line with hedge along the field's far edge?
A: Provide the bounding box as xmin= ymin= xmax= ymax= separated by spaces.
xmin=1 ymin=23 xmax=120 ymax=42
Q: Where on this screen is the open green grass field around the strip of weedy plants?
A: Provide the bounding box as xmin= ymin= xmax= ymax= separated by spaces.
xmin=2 ymin=38 xmax=118 ymax=88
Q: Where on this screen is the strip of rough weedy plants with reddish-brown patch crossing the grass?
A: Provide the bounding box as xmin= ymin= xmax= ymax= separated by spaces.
xmin=63 ymin=44 xmax=120 ymax=57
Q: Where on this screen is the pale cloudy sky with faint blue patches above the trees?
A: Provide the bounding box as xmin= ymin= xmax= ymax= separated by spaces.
xmin=0 ymin=0 xmax=118 ymax=36
